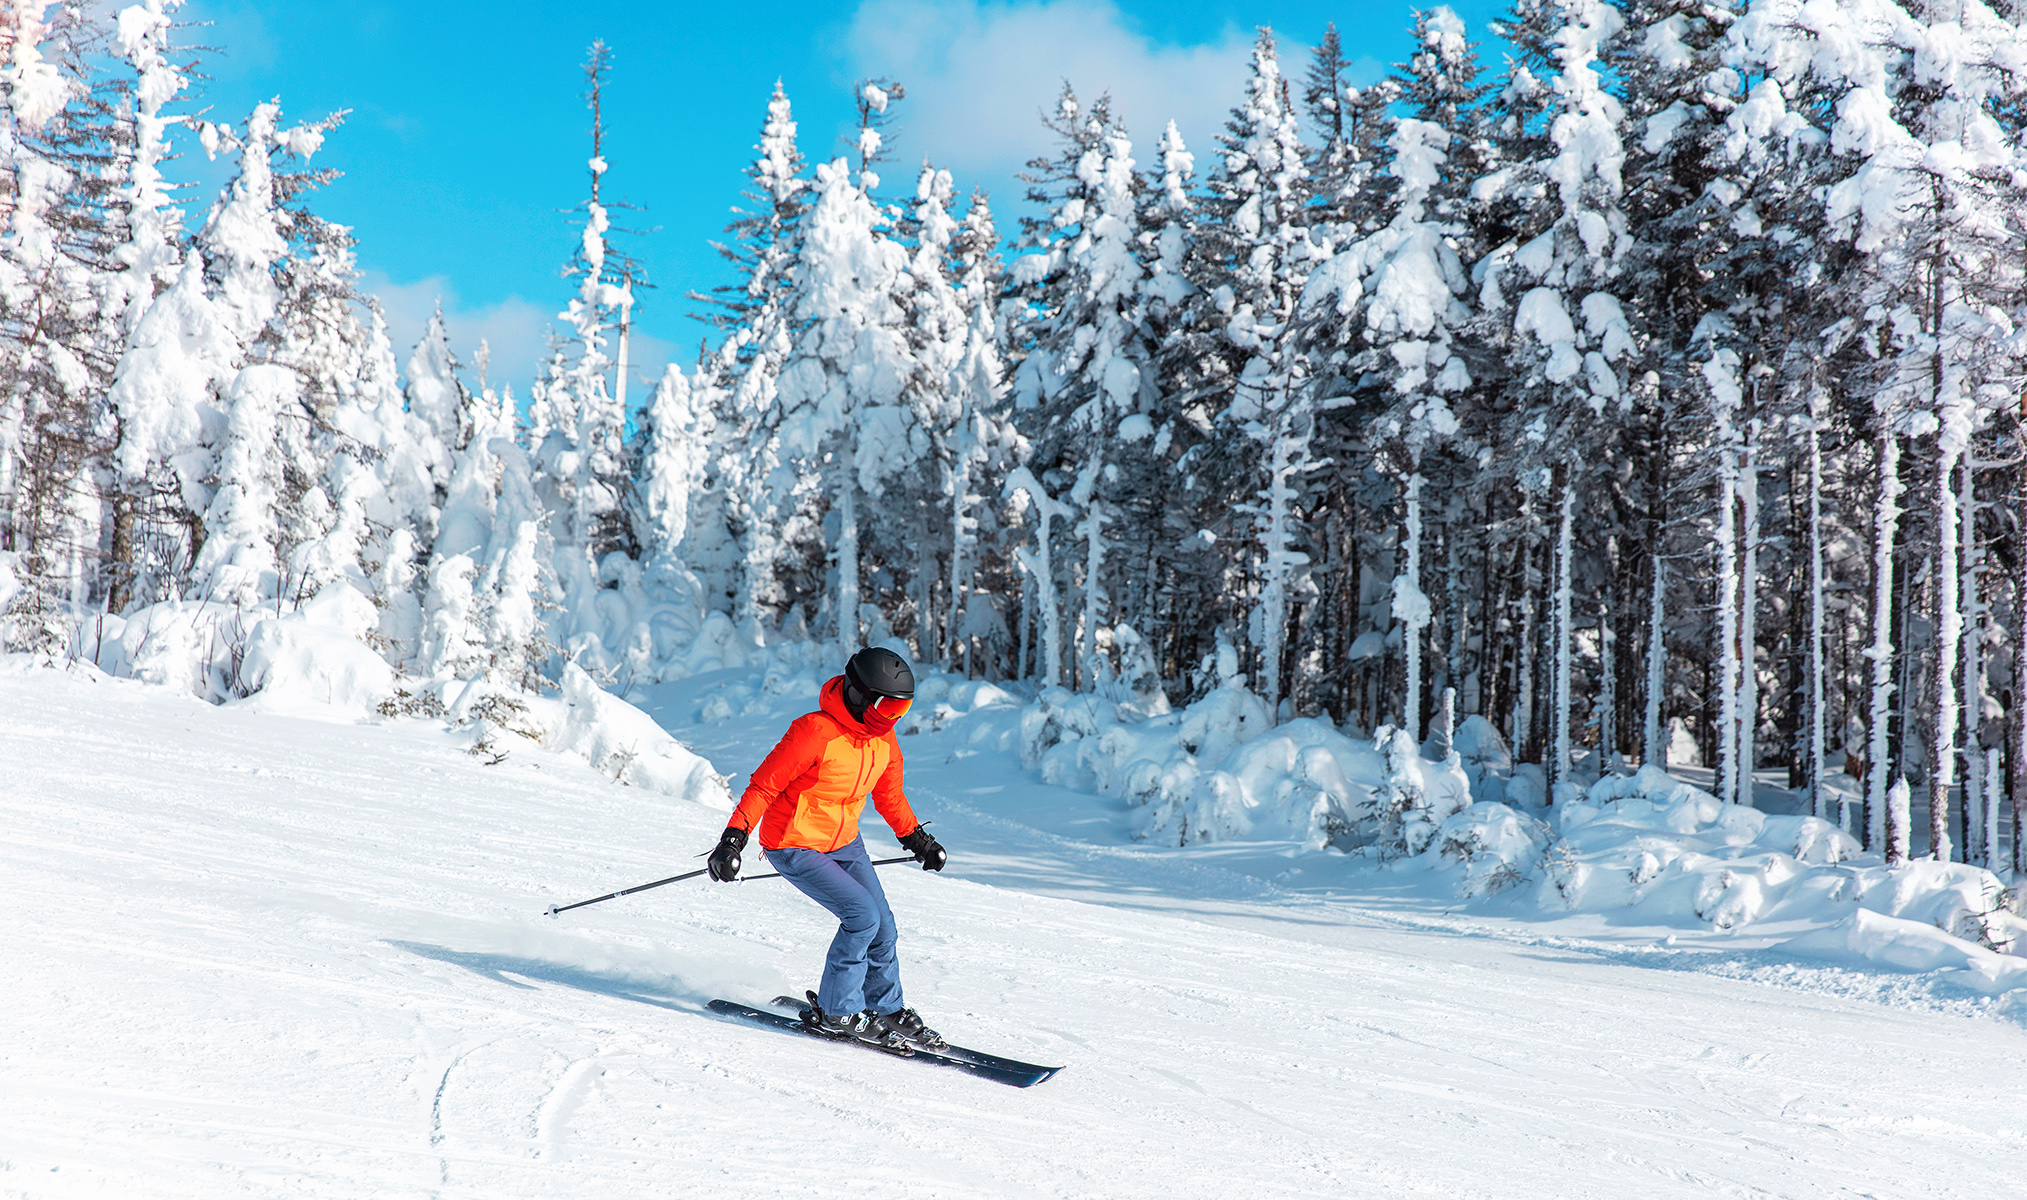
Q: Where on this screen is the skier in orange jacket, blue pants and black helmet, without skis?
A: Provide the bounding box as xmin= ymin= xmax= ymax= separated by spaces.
xmin=709 ymin=647 xmax=949 ymax=1048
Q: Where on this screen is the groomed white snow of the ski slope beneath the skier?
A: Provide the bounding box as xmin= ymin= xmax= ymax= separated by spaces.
xmin=0 ymin=661 xmax=2027 ymax=1198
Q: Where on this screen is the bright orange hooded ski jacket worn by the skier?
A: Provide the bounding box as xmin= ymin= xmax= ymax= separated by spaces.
xmin=730 ymin=675 xmax=920 ymax=853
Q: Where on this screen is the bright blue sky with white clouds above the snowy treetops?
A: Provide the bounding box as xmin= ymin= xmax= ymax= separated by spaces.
xmin=180 ymin=0 xmax=1502 ymax=389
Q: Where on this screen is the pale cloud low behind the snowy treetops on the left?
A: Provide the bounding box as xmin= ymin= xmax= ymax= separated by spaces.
xmin=359 ymin=270 xmax=675 ymax=407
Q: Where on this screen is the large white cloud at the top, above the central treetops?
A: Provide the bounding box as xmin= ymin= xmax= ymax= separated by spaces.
xmin=845 ymin=0 xmax=1248 ymax=174
